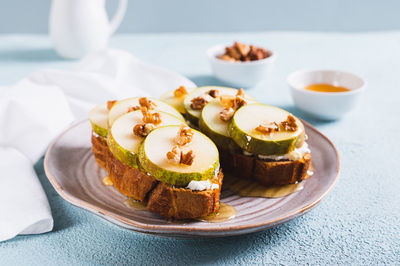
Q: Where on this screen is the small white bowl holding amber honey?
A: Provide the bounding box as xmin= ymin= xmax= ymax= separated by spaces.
xmin=287 ymin=70 xmax=365 ymax=120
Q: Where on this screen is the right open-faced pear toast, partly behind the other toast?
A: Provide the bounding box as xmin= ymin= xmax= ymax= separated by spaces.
xmin=177 ymin=87 xmax=311 ymax=185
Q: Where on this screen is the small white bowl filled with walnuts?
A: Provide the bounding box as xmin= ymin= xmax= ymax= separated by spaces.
xmin=207 ymin=44 xmax=276 ymax=88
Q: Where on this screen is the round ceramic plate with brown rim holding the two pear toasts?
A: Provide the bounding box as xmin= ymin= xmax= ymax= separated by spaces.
xmin=44 ymin=121 xmax=340 ymax=237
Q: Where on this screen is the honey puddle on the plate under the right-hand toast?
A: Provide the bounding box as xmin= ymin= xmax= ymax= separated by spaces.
xmin=224 ymin=176 xmax=303 ymax=198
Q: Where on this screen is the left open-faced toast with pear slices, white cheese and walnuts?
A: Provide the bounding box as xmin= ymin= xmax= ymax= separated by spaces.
xmin=90 ymin=98 xmax=223 ymax=219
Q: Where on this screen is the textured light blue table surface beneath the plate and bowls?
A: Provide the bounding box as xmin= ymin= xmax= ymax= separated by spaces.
xmin=0 ymin=32 xmax=400 ymax=265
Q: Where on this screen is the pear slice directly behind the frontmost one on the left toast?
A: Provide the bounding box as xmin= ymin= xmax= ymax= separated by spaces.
xmin=107 ymin=110 xmax=185 ymax=168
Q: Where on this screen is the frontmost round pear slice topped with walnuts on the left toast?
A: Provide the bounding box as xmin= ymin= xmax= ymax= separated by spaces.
xmin=139 ymin=126 xmax=219 ymax=186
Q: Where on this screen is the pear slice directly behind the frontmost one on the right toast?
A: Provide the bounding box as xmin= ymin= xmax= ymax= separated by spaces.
xmin=199 ymin=99 xmax=238 ymax=150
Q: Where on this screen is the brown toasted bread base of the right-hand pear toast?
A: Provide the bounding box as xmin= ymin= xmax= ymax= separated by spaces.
xmin=220 ymin=149 xmax=311 ymax=186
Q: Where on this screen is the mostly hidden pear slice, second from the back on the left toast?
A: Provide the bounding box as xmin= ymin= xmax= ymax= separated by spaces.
xmin=108 ymin=97 xmax=184 ymax=127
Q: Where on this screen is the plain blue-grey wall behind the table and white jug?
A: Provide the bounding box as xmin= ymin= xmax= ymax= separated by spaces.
xmin=0 ymin=0 xmax=400 ymax=33
